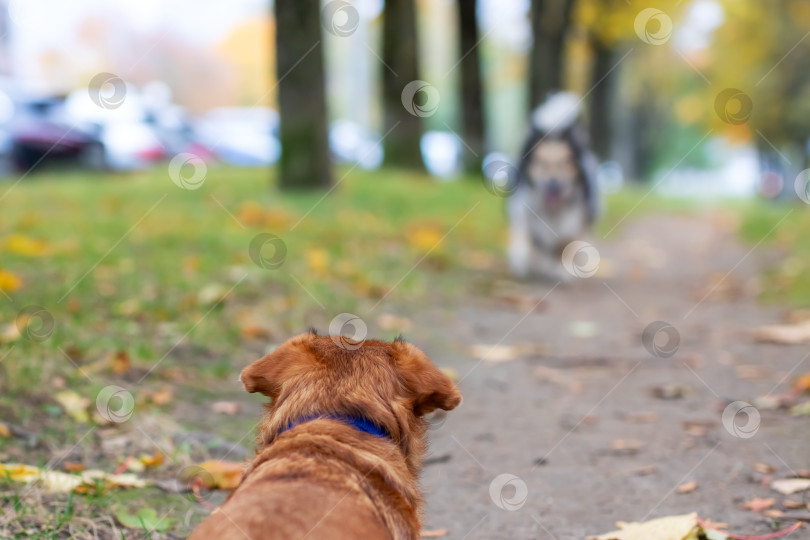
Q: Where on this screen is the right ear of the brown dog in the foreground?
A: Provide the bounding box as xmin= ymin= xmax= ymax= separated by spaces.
xmin=391 ymin=340 xmax=461 ymax=416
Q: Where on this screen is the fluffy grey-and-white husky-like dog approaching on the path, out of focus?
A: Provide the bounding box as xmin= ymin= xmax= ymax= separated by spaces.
xmin=507 ymin=93 xmax=599 ymax=281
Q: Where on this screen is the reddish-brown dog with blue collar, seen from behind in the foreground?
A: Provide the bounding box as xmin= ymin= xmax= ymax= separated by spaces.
xmin=185 ymin=332 xmax=461 ymax=540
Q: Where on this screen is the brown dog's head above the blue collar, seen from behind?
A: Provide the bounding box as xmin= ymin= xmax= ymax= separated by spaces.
xmin=240 ymin=332 xmax=461 ymax=467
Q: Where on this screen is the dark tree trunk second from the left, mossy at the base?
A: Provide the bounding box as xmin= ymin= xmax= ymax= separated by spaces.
xmin=383 ymin=0 xmax=424 ymax=169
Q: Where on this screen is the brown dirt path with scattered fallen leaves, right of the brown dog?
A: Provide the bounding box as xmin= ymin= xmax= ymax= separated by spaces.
xmin=412 ymin=216 xmax=810 ymax=539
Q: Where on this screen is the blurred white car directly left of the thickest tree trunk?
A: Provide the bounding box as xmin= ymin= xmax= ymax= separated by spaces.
xmin=194 ymin=107 xmax=281 ymax=167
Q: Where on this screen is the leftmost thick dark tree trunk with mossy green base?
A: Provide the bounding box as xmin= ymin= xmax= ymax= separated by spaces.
xmin=275 ymin=0 xmax=332 ymax=189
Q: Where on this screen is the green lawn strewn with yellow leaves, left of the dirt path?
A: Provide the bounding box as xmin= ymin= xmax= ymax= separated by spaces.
xmin=0 ymin=168 xmax=748 ymax=538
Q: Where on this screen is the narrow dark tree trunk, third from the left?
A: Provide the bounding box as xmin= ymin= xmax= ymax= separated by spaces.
xmin=457 ymin=0 xmax=484 ymax=173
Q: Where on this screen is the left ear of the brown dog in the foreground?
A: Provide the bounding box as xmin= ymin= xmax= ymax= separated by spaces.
xmin=239 ymin=333 xmax=317 ymax=401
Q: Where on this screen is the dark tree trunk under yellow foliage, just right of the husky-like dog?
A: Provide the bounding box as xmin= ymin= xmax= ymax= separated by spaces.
xmin=588 ymin=38 xmax=614 ymax=160
